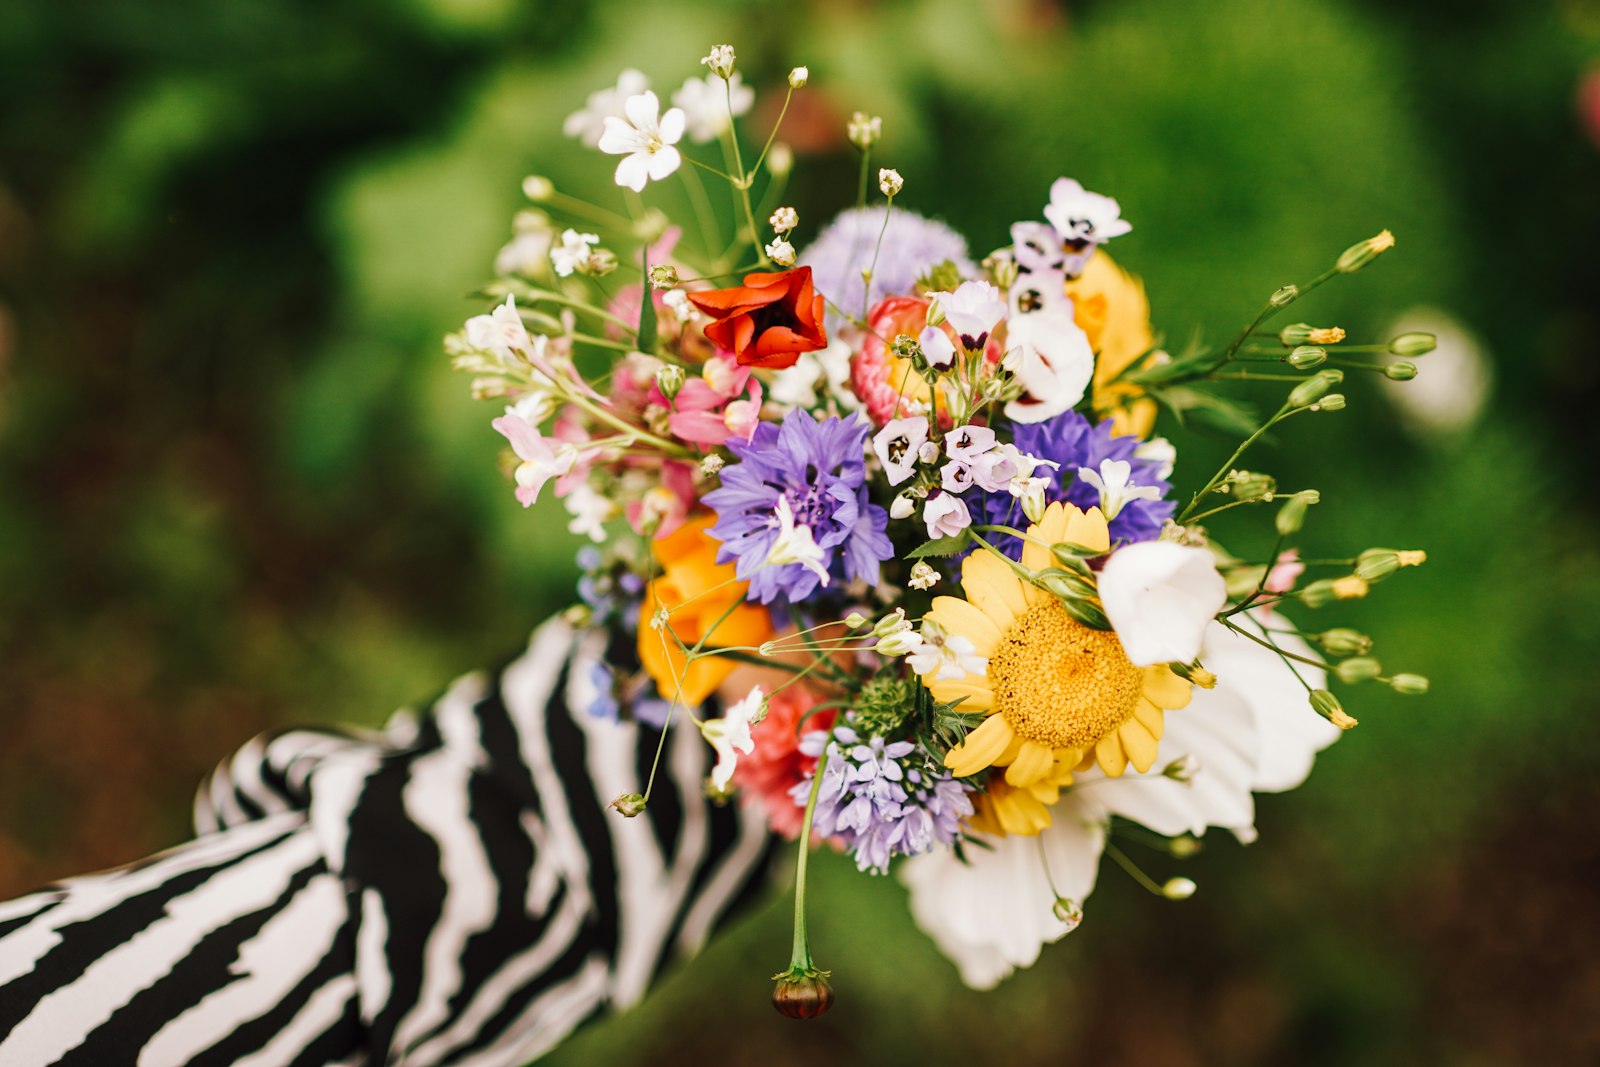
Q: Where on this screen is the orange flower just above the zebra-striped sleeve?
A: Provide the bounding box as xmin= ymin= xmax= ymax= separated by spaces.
xmin=638 ymin=515 xmax=773 ymax=705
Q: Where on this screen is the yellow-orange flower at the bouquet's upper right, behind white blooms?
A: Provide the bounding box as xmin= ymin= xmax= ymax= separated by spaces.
xmin=1067 ymin=248 xmax=1155 ymax=437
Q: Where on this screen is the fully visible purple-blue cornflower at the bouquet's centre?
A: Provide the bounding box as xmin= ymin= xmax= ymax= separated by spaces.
xmin=704 ymin=408 xmax=894 ymax=603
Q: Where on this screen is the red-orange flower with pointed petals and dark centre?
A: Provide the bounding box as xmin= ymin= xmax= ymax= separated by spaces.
xmin=688 ymin=267 xmax=827 ymax=368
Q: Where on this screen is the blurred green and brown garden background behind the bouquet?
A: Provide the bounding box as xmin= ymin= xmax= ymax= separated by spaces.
xmin=0 ymin=0 xmax=1600 ymax=1065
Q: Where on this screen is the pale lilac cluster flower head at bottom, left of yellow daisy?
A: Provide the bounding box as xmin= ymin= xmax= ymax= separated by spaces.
xmin=789 ymin=716 xmax=973 ymax=875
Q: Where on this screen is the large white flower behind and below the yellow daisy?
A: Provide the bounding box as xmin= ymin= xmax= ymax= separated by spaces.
xmin=901 ymin=616 xmax=1339 ymax=989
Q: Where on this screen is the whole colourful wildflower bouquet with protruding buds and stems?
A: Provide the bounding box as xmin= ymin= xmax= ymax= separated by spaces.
xmin=446 ymin=45 xmax=1434 ymax=1017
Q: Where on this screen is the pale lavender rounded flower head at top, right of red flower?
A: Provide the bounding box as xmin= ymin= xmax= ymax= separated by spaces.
xmin=800 ymin=206 xmax=974 ymax=330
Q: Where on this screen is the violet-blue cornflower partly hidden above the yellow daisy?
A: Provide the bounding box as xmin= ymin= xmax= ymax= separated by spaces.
xmin=974 ymin=404 xmax=1176 ymax=547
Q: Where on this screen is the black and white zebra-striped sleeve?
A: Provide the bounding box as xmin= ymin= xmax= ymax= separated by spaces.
xmin=0 ymin=622 xmax=771 ymax=1067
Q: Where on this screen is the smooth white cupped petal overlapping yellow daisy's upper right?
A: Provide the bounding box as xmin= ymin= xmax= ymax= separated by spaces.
xmin=1099 ymin=541 xmax=1227 ymax=667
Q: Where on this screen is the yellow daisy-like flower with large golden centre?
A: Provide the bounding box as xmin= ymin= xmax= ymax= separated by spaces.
xmin=923 ymin=504 xmax=1189 ymax=833
